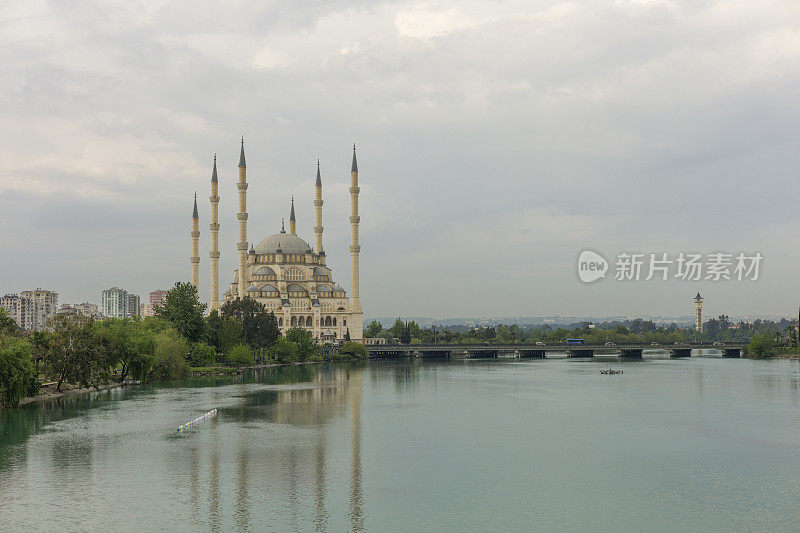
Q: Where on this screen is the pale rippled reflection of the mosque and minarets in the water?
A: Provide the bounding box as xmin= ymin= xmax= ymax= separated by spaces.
xmin=188 ymin=365 xmax=364 ymax=531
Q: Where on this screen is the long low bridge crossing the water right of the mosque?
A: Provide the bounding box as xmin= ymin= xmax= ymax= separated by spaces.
xmin=367 ymin=342 xmax=747 ymax=359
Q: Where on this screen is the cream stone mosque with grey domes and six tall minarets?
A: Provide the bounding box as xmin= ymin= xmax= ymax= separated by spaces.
xmin=189 ymin=138 xmax=364 ymax=342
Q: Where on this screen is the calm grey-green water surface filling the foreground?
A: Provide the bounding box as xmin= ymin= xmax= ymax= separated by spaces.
xmin=0 ymin=357 xmax=800 ymax=531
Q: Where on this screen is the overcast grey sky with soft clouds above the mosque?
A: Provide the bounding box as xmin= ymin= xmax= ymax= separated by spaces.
xmin=0 ymin=0 xmax=800 ymax=317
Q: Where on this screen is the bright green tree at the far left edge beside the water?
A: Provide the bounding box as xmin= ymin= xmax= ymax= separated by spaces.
xmin=0 ymin=336 xmax=39 ymax=407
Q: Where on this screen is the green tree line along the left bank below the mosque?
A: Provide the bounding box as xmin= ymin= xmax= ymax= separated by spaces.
xmin=0 ymin=283 xmax=367 ymax=406
